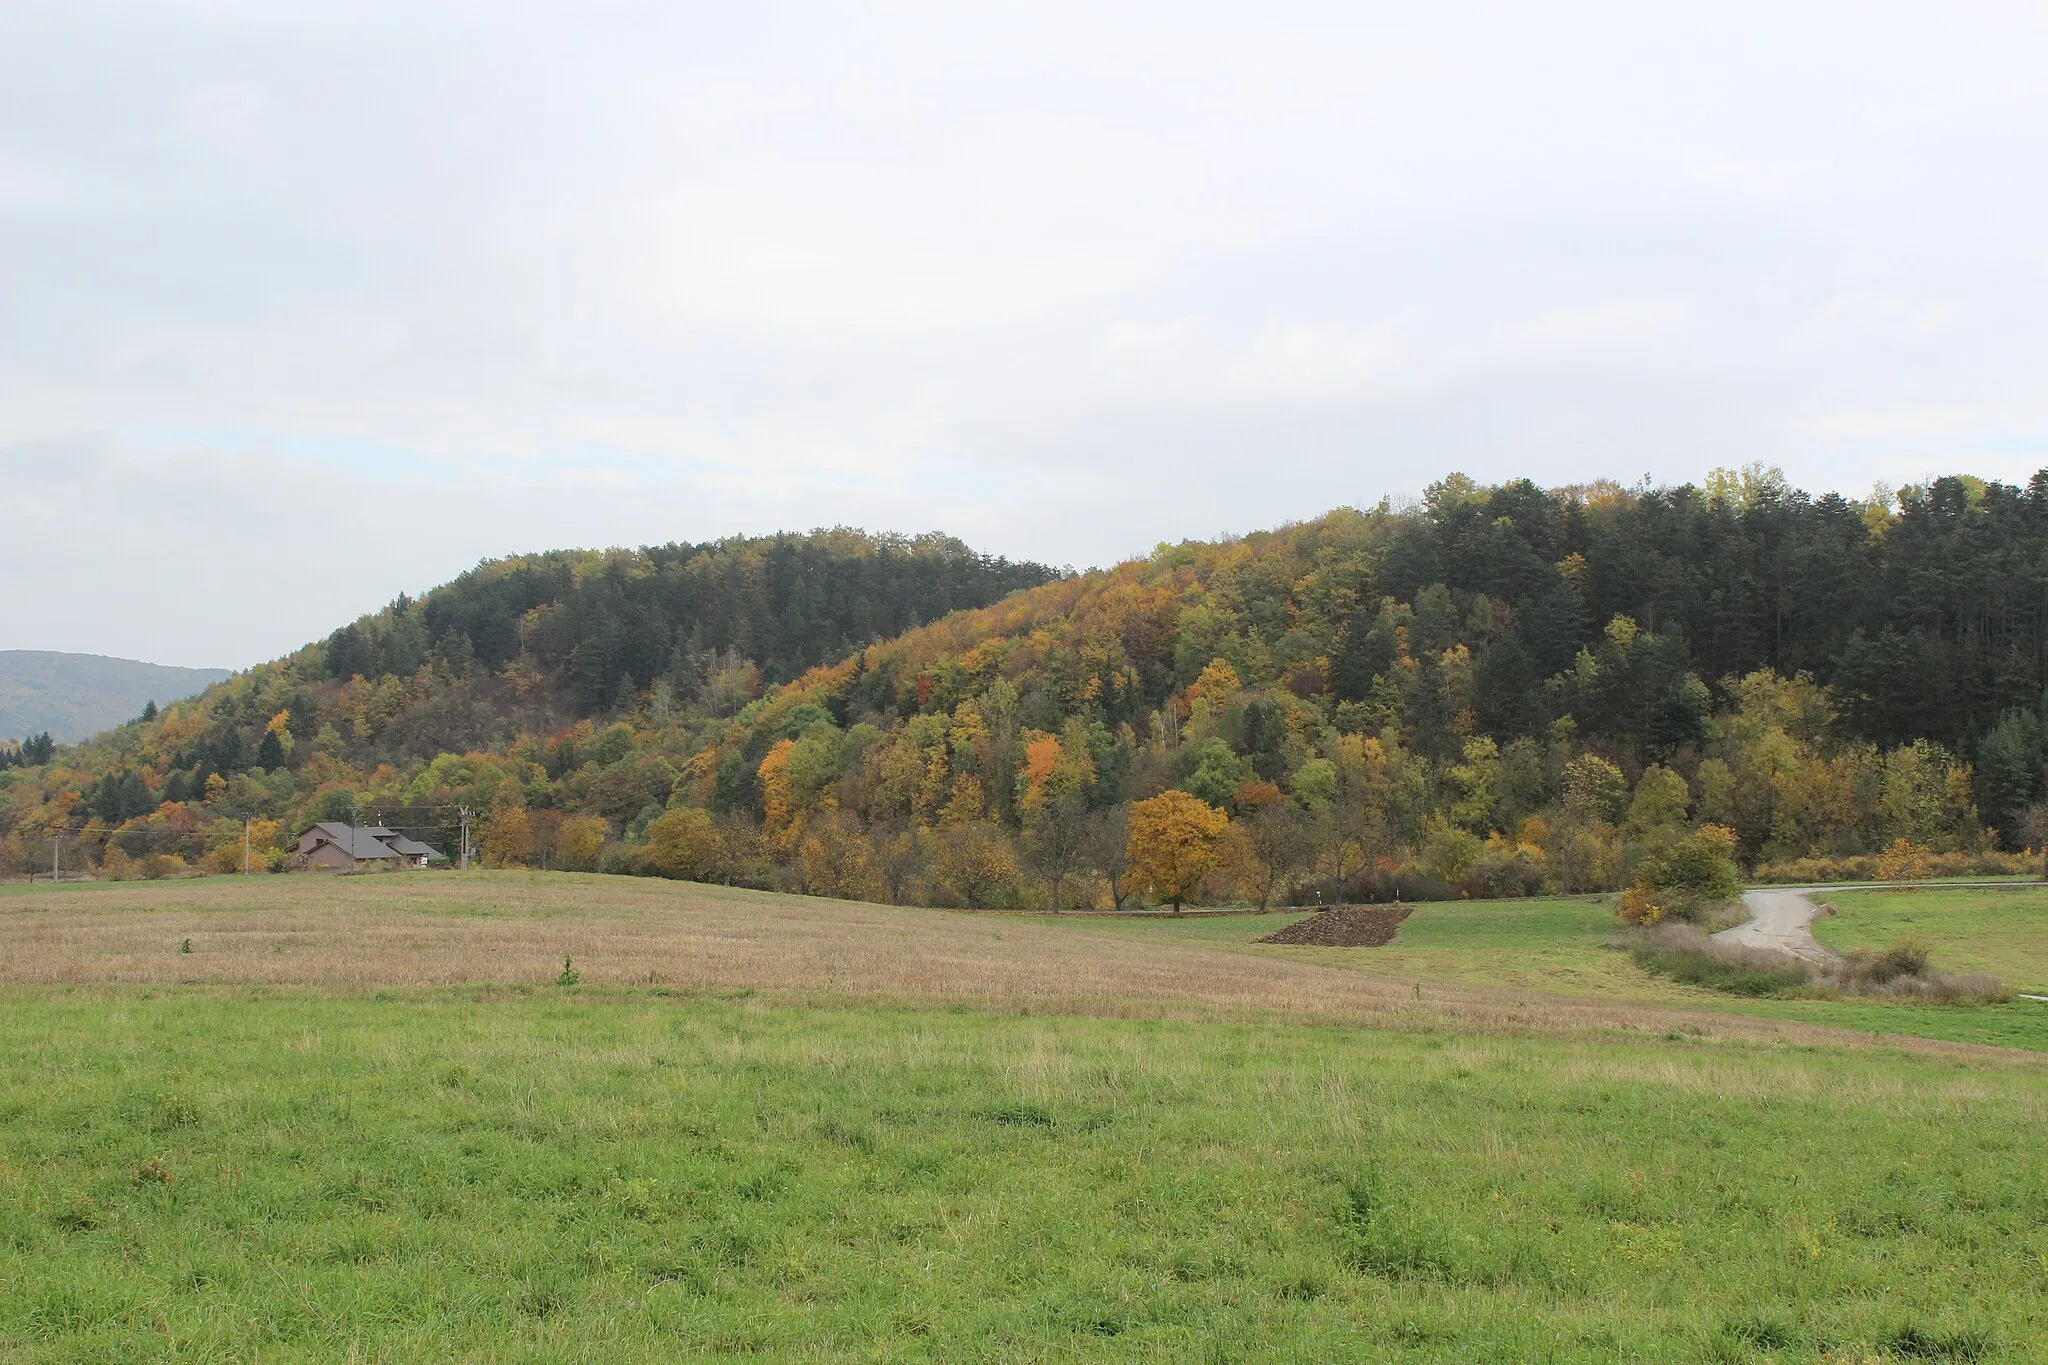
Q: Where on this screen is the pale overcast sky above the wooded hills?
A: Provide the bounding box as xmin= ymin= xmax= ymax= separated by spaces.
xmin=0 ymin=0 xmax=2048 ymax=667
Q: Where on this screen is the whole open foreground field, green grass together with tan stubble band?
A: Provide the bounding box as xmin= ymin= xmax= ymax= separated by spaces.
xmin=0 ymin=874 xmax=2048 ymax=1361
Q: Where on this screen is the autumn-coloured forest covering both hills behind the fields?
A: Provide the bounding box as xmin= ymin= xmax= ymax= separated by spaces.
xmin=12 ymin=469 xmax=2048 ymax=907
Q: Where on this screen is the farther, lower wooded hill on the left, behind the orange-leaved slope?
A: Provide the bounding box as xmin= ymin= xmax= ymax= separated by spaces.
xmin=0 ymin=528 xmax=1057 ymax=833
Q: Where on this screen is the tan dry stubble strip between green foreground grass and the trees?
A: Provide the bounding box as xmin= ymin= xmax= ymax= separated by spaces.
xmin=0 ymin=874 xmax=2040 ymax=1062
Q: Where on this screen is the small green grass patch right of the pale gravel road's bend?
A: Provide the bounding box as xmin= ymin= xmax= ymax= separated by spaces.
xmin=1812 ymin=882 xmax=2048 ymax=995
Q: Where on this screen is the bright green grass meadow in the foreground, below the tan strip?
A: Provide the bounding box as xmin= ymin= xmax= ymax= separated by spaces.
xmin=0 ymin=986 xmax=2048 ymax=1361
